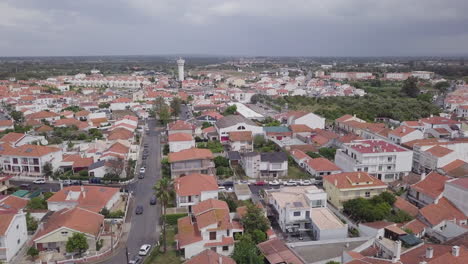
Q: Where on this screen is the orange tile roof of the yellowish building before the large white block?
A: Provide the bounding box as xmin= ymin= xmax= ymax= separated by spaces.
xmin=323 ymin=172 xmax=387 ymax=189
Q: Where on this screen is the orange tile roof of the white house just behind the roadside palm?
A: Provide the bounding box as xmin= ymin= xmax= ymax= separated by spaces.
xmin=174 ymin=173 xmax=218 ymax=196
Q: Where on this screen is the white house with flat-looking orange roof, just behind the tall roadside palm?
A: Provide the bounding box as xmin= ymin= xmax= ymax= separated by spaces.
xmin=174 ymin=173 xmax=218 ymax=212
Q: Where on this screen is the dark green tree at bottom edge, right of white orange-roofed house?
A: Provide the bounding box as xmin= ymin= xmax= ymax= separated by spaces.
xmin=232 ymin=234 xmax=263 ymax=264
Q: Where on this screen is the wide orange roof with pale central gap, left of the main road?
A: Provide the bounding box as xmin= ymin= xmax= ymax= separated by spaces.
xmin=47 ymin=186 xmax=120 ymax=213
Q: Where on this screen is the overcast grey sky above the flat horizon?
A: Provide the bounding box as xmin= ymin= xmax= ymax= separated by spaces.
xmin=0 ymin=0 xmax=468 ymax=56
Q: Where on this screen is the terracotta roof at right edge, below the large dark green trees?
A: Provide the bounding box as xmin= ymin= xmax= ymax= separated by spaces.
xmin=419 ymin=197 xmax=467 ymax=226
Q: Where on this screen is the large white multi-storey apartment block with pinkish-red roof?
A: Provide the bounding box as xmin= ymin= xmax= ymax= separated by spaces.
xmin=335 ymin=140 xmax=413 ymax=182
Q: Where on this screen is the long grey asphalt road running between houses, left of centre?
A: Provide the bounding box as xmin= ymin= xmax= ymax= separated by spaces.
xmin=102 ymin=120 xmax=161 ymax=264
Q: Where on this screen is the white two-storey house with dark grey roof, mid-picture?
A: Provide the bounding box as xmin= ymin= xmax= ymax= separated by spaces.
xmin=241 ymin=152 xmax=288 ymax=178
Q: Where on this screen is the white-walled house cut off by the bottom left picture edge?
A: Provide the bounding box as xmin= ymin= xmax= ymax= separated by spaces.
xmin=0 ymin=209 xmax=28 ymax=263
